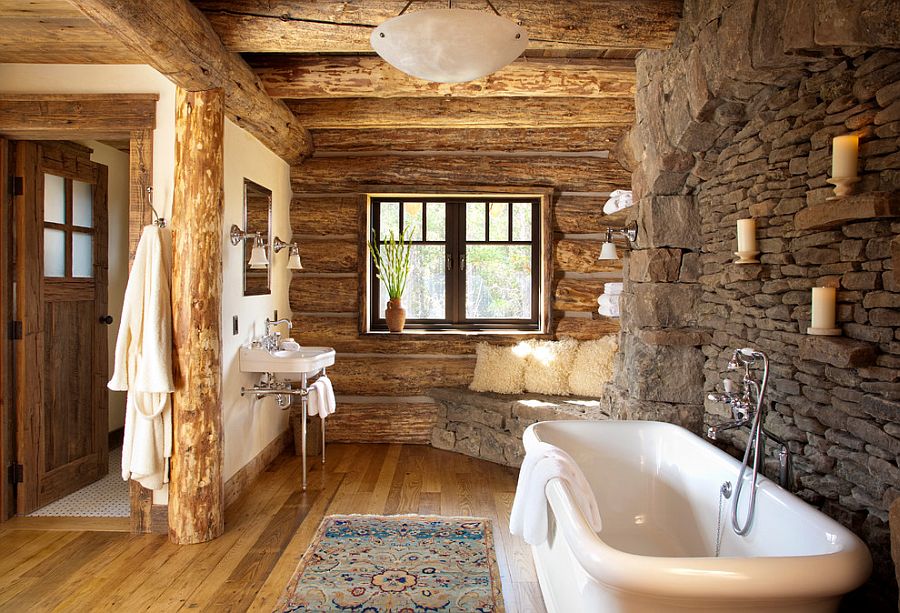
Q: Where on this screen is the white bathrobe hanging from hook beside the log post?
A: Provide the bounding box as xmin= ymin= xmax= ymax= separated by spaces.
xmin=108 ymin=225 xmax=174 ymax=490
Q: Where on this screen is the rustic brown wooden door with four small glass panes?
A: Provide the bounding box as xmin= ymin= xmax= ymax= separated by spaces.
xmin=15 ymin=141 xmax=109 ymax=514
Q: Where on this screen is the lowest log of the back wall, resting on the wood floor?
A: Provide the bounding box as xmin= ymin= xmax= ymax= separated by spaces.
xmin=325 ymin=402 xmax=437 ymax=445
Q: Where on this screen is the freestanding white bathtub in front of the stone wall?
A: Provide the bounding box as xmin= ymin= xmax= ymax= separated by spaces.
xmin=524 ymin=421 xmax=872 ymax=613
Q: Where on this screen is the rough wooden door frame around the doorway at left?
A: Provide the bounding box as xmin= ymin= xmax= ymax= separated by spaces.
xmin=0 ymin=94 xmax=162 ymax=532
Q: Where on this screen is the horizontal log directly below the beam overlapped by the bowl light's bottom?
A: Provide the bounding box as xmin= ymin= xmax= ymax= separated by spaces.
xmin=285 ymin=98 xmax=634 ymax=129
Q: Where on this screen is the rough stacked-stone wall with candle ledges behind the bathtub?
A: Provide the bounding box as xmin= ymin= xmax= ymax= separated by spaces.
xmin=610 ymin=0 xmax=900 ymax=610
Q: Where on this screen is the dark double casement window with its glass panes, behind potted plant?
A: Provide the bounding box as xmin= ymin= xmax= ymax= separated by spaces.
xmin=368 ymin=194 xmax=545 ymax=332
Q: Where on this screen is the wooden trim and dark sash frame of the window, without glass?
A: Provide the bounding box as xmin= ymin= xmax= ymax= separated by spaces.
xmin=360 ymin=190 xmax=552 ymax=335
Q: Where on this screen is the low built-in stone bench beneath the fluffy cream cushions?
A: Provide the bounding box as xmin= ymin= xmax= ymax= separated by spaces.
xmin=428 ymin=387 xmax=610 ymax=467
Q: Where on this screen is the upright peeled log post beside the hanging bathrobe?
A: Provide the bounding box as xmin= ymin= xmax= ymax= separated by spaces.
xmin=169 ymin=88 xmax=225 ymax=544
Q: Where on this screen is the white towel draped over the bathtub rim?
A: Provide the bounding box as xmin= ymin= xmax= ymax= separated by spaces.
xmin=509 ymin=442 xmax=602 ymax=545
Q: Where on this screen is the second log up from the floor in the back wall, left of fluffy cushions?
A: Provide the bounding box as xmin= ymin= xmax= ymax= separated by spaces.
xmin=326 ymin=355 xmax=475 ymax=394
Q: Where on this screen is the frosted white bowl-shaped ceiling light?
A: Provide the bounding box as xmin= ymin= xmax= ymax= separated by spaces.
xmin=370 ymin=0 xmax=528 ymax=83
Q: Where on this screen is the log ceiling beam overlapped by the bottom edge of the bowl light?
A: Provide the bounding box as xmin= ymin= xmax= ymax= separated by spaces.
xmin=251 ymin=55 xmax=637 ymax=98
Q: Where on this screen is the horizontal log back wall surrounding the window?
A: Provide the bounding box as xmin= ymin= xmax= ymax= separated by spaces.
xmin=290 ymin=123 xmax=631 ymax=443
